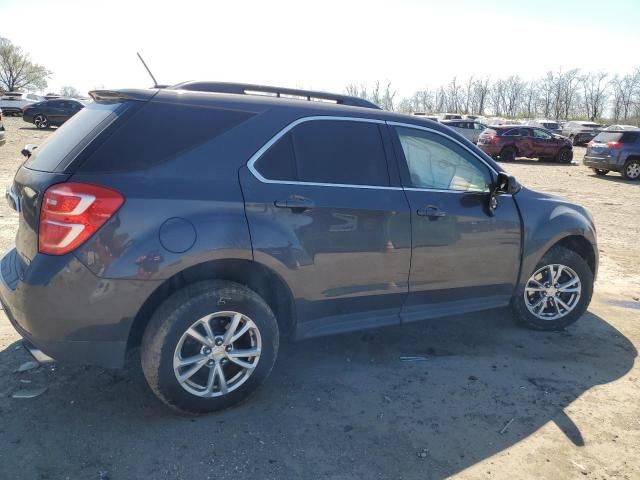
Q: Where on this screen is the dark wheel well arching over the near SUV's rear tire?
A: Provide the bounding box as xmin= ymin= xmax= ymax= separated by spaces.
xmin=127 ymin=260 xmax=295 ymax=349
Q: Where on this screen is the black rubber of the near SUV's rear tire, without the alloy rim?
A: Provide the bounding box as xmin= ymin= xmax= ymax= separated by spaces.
xmin=142 ymin=282 xmax=279 ymax=413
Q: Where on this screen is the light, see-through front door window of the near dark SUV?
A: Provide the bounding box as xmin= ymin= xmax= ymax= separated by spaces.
xmin=396 ymin=127 xmax=491 ymax=192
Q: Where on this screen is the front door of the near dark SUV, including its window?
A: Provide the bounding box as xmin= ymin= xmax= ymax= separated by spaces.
xmin=391 ymin=125 xmax=520 ymax=321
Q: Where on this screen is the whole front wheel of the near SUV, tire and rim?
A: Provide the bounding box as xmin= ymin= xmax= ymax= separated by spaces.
xmin=511 ymin=246 xmax=593 ymax=331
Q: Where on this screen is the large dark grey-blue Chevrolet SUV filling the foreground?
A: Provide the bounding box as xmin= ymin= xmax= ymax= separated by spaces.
xmin=0 ymin=82 xmax=598 ymax=412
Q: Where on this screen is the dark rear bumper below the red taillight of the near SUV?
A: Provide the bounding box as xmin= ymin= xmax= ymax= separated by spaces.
xmin=0 ymin=249 xmax=158 ymax=368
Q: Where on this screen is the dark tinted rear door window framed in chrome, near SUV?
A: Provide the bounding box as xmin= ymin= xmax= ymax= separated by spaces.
xmin=255 ymin=120 xmax=389 ymax=186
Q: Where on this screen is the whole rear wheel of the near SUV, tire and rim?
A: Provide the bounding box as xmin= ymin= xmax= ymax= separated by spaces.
xmin=141 ymin=280 xmax=279 ymax=414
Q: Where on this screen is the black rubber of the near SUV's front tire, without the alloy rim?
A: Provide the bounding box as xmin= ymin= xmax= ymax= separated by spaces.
xmin=511 ymin=246 xmax=594 ymax=330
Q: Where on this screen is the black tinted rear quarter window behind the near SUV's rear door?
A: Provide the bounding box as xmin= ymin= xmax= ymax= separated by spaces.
xmin=81 ymin=101 xmax=254 ymax=173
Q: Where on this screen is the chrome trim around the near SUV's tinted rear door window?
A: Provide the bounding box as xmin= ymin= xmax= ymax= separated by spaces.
xmin=247 ymin=115 xmax=402 ymax=191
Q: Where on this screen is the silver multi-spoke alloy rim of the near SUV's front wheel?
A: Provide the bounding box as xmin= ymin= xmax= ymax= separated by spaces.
xmin=524 ymin=264 xmax=582 ymax=320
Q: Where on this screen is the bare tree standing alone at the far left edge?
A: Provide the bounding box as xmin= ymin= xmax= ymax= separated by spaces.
xmin=0 ymin=37 xmax=51 ymax=92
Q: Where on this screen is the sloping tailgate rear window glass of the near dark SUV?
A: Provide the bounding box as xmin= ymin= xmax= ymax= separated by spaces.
xmin=24 ymin=102 xmax=129 ymax=172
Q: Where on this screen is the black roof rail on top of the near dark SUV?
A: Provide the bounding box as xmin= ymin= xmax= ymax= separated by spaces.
xmin=169 ymin=81 xmax=380 ymax=110
